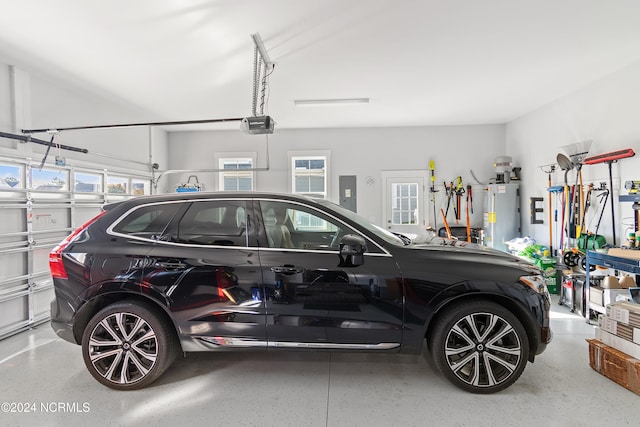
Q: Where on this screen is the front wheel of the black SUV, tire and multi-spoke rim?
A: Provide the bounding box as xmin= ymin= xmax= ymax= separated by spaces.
xmin=429 ymin=300 xmax=529 ymax=394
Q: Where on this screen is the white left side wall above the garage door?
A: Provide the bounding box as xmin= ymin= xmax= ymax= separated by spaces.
xmin=0 ymin=61 xmax=167 ymax=173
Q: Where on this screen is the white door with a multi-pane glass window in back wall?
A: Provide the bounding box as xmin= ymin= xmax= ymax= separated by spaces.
xmin=383 ymin=172 xmax=427 ymax=234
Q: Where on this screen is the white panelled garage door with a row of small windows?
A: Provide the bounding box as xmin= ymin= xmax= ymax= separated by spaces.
xmin=0 ymin=157 xmax=151 ymax=339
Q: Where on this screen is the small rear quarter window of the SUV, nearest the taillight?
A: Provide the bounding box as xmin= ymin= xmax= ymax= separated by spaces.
xmin=113 ymin=203 xmax=182 ymax=238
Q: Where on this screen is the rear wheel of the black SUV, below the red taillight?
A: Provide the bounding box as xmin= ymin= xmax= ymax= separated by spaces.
xmin=82 ymin=301 xmax=179 ymax=390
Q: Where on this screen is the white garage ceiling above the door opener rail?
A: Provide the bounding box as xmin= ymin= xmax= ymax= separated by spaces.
xmin=0 ymin=0 xmax=640 ymax=128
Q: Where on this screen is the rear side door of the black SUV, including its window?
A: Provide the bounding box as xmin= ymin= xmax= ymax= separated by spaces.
xmin=145 ymin=199 xmax=266 ymax=351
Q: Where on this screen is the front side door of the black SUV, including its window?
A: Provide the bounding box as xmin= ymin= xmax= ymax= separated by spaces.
xmin=256 ymin=199 xmax=402 ymax=349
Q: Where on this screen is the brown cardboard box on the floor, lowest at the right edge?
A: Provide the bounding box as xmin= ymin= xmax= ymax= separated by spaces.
xmin=587 ymin=339 xmax=640 ymax=394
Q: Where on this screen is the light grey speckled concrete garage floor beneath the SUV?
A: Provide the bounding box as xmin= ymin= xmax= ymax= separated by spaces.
xmin=0 ymin=297 xmax=640 ymax=427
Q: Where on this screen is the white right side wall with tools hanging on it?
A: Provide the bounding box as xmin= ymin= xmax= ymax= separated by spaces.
xmin=506 ymin=58 xmax=640 ymax=246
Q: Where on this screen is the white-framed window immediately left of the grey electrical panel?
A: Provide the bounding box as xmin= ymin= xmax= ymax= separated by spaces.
xmin=291 ymin=156 xmax=327 ymax=199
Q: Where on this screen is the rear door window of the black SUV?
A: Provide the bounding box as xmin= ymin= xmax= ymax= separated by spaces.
xmin=177 ymin=200 xmax=248 ymax=246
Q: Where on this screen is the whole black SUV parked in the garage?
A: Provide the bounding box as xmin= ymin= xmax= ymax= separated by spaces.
xmin=49 ymin=193 xmax=552 ymax=393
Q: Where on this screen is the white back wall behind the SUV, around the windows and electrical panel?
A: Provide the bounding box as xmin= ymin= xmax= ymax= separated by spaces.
xmin=168 ymin=123 xmax=505 ymax=231
